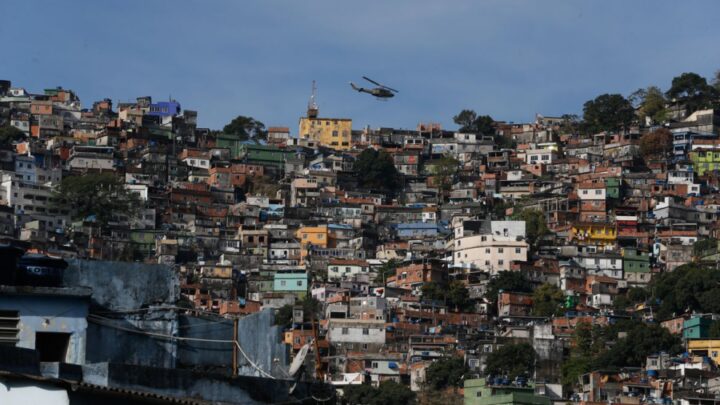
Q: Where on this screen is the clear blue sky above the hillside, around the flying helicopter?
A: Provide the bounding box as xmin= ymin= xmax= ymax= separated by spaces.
xmin=0 ymin=0 xmax=720 ymax=134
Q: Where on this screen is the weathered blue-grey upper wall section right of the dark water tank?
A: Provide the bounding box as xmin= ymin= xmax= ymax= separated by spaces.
xmin=63 ymin=260 xmax=180 ymax=310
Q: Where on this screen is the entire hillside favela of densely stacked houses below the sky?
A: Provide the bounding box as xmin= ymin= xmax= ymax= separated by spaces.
xmin=0 ymin=73 xmax=720 ymax=405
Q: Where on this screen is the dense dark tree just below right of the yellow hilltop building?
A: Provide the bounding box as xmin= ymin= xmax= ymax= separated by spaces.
xmin=353 ymin=148 xmax=400 ymax=191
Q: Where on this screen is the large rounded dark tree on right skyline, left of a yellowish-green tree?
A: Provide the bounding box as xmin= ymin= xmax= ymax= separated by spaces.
xmin=583 ymin=94 xmax=635 ymax=133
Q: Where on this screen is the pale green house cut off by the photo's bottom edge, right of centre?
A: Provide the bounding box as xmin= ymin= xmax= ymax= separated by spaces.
xmin=464 ymin=378 xmax=552 ymax=405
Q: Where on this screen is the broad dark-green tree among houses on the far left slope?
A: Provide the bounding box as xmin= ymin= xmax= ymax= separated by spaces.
xmin=54 ymin=173 xmax=139 ymax=226
